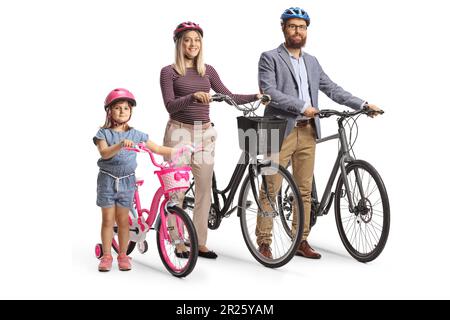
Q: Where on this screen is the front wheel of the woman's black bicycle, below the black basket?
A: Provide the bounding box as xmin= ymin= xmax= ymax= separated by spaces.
xmin=238 ymin=162 xmax=304 ymax=268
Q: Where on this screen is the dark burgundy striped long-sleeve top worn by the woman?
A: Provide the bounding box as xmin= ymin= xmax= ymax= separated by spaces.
xmin=160 ymin=65 xmax=257 ymax=124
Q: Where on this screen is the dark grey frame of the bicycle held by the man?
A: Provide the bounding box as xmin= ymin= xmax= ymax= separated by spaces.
xmin=316 ymin=118 xmax=364 ymax=216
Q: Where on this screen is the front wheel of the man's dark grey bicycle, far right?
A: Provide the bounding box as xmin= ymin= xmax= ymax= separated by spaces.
xmin=334 ymin=160 xmax=390 ymax=262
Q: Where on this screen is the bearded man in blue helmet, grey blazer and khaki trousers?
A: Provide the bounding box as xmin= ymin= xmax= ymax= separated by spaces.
xmin=256 ymin=7 xmax=380 ymax=259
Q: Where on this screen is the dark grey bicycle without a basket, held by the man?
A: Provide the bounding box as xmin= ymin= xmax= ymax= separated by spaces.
xmin=278 ymin=108 xmax=390 ymax=262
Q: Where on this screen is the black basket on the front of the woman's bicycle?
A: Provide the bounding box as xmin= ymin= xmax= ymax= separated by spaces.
xmin=237 ymin=117 xmax=287 ymax=156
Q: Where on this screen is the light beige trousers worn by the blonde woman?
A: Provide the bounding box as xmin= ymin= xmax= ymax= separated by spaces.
xmin=164 ymin=120 xmax=217 ymax=246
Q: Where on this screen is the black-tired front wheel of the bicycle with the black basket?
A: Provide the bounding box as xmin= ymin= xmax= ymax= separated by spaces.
xmin=238 ymin=162 xmax=304 ymax=268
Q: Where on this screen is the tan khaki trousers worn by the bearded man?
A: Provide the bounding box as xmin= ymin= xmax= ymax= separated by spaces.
xmin=256 ymin=124 xmax=316 ymax=246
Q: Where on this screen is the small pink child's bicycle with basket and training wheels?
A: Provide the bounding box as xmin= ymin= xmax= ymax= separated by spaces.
xmin=95 ymin=143 xmax=198 ymax=277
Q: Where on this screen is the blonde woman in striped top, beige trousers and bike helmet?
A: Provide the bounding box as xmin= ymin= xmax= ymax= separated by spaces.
xmin=160 ymin=22 xmax=262 ymax=259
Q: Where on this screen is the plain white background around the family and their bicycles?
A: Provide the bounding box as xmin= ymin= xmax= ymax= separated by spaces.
xmin=0 ymin=0 xmax=450 ymax=299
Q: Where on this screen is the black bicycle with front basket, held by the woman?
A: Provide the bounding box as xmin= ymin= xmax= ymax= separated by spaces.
xmin=183 ymin=94 xmax=304 ymax=268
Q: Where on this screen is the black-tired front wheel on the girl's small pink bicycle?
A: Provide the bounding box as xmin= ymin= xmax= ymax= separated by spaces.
xmin=155 ymin=206 xmax=198 ymax=278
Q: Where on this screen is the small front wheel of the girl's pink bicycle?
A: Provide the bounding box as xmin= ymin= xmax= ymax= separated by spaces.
xmin=156 ymin=207 xmax=198 ymax=277
